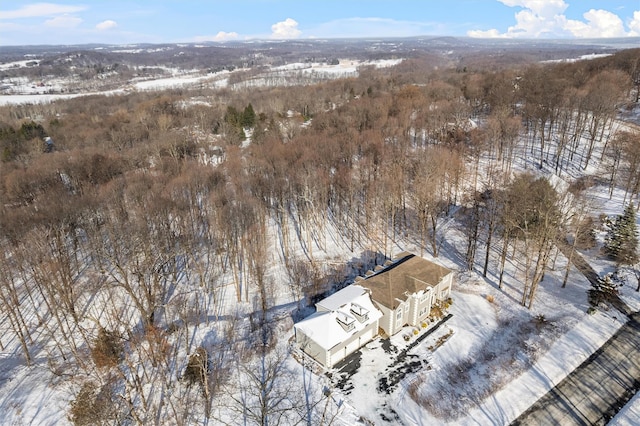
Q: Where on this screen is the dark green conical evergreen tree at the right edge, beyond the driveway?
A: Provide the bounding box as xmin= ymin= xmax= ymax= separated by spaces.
xmin=605 ymin=203 xmax=638 ymax=265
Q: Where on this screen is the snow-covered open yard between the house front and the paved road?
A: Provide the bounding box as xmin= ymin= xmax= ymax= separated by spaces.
xmin=330 ymin=246 xmax=639 ymax=425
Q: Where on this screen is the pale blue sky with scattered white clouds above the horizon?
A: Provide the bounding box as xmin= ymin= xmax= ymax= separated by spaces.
xmin=0 ymin=0 xmax=640 ymax=46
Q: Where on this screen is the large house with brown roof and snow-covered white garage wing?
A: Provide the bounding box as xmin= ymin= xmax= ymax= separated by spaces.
xmin=294 ymin=253 xmax=453 ymax=367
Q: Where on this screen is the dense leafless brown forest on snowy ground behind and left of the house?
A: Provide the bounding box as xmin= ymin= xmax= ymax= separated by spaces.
xmin=0 ymin=45 xmax=640 ymax=424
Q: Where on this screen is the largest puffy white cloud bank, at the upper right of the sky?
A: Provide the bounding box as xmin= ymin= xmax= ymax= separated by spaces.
xmin=467 ymin=0 xmax=640 ymax=38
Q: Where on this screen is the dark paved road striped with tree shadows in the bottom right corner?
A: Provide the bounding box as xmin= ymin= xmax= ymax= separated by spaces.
xmin=512 ymin=312 xmax=640 ymax=426
